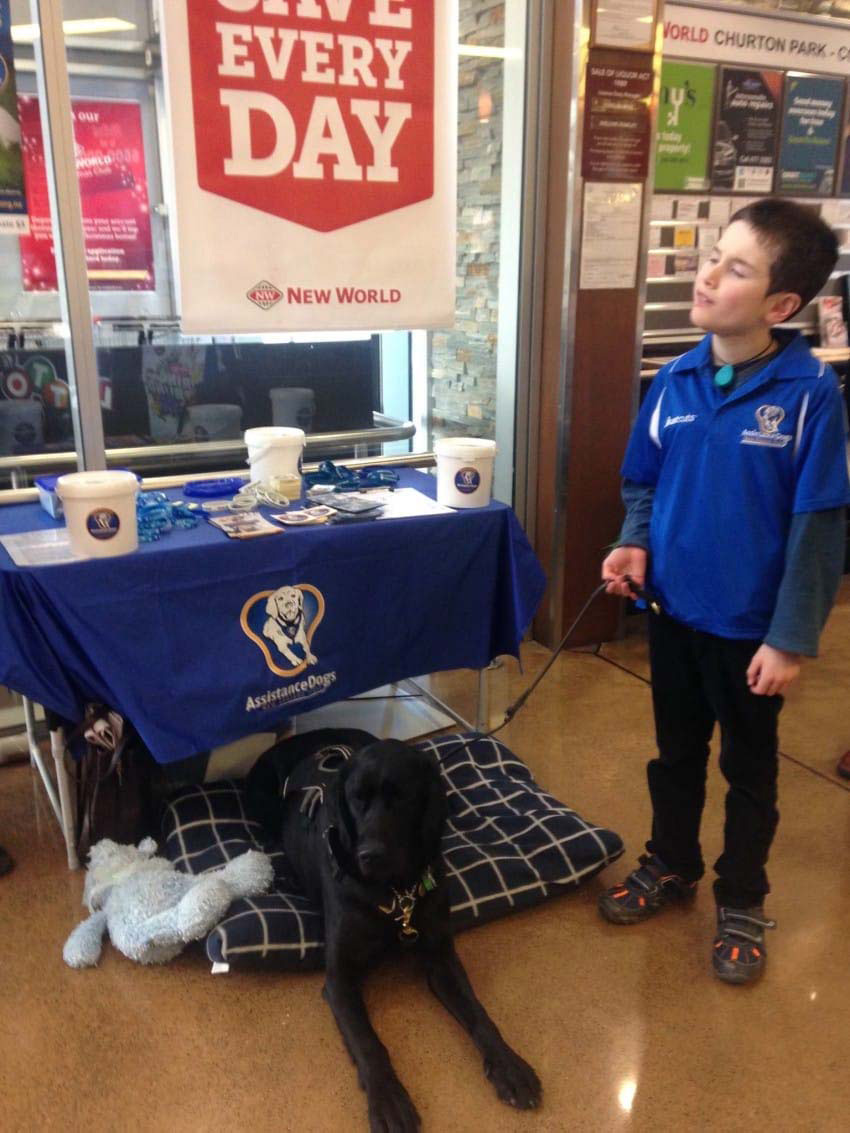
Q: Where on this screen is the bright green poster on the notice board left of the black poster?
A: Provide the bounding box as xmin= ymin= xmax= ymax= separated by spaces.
xmin=655 ymin=61 xmax=715 ymax=193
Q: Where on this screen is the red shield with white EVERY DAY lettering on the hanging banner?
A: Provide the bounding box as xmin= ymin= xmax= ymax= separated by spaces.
xmin=187 ymin=0 xmax=434 ymax=232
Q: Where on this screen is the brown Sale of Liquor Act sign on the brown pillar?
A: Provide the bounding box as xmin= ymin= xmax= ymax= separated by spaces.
xmin=581 ymin=51 xmax=653 ymax=181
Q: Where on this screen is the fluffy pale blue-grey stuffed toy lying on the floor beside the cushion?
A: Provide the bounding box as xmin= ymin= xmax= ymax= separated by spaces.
xmin=62 ymin=838 xmax=272 ymax=968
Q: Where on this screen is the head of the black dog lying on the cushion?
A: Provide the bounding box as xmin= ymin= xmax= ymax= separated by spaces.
xmin=329 ymin=740 xmax=447 ymax=885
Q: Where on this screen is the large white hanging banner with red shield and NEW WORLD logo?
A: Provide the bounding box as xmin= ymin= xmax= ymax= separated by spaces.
xmin=161 ymin=0 xmax=458 ymax=333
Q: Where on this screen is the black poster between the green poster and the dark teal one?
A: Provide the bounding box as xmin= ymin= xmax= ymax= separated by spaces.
xmin=712 ymin=67 xmax=782 ymax=193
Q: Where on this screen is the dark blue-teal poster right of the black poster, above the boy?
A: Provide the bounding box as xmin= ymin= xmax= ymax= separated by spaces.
xmin=776 ymin=75 xmax=844 ymax=197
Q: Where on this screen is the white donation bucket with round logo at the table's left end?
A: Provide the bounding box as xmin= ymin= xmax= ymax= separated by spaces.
xmin=56 ymin=469 xmax=138 ymax=559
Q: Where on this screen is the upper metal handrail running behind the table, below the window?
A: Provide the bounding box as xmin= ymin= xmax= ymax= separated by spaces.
xmin=0 ymin=412 xmax=416 ymax=472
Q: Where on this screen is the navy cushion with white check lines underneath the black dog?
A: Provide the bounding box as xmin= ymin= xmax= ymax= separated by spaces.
xmin=162 ymin=735 xmax=623 ymax=968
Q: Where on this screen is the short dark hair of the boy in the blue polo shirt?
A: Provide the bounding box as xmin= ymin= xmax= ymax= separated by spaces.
xmin=729 ymin=197 xmax=839 ymax=307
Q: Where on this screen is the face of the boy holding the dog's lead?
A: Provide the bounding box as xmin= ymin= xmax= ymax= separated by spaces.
xmin=690 ymin=220 xmax=800 ymax=338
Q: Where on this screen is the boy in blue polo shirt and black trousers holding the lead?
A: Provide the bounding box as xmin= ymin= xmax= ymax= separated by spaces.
xmin=600 ymin=197 xmax=850 ymax=983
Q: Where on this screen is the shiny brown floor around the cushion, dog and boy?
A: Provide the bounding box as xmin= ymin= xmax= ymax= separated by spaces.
xmin=0 ymin=582 xmax=850 ymax=1133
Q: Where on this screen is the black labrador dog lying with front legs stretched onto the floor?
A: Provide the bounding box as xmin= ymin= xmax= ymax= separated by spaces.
xmin=248 ymin=729 xmax=542 ymax=1133
